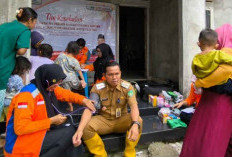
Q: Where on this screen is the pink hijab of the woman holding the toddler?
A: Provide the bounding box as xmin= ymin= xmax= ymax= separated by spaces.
xmin=216 ymin=24 xmax=232 ymax=50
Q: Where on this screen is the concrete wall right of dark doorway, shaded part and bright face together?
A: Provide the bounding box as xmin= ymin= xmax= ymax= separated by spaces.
xmin=150 ymin=0 xmax=205 ymax=96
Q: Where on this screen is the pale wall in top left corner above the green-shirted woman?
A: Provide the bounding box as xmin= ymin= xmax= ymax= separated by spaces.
xmin=0 ymin=0 xmax=31 ymax=24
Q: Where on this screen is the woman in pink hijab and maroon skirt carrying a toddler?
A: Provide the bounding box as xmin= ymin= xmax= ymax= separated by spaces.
xmin=180 ymin=24 xmax=232 ymax=157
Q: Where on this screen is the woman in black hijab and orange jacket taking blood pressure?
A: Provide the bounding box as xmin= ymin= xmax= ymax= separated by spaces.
xmin=4 ymin=64 xmax=95 ymax=157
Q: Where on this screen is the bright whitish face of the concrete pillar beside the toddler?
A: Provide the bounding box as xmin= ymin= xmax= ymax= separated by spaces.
xmin=179 ymin=0 xmax=205 ymax=96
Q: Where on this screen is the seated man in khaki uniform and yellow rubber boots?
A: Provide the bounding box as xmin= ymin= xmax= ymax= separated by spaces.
xmin=73 ymin=62 xmax=142 ymax=157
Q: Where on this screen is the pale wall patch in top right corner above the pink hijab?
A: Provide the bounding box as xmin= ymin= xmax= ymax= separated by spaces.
xmin=213 ymin=0 xmax=232 ymax=28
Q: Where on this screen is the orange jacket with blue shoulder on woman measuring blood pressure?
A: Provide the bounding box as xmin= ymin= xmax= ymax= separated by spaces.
xmin=4 ymin=84 xmax=85 ymax=157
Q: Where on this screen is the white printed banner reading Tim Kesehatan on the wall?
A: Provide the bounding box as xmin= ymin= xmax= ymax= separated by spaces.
xmin=33 ymin=0 xmax=116 ymax=55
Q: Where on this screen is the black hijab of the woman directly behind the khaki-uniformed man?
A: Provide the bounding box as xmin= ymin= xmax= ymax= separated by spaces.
xmin=93 ymin=43 xmax=114 ymax=82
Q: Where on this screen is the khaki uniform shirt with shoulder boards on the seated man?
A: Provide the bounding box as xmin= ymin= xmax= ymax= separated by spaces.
xmin=90 ymin=80 xmax=138 ymax=119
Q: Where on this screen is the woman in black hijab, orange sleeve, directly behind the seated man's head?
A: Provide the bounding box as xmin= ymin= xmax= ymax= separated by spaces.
xmin=82 ymin=43 xmax=114 ymax=83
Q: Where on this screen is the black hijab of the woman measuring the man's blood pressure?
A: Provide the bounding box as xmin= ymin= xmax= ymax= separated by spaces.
xmin=31 ymin=64 xmax=66 ymax=118
